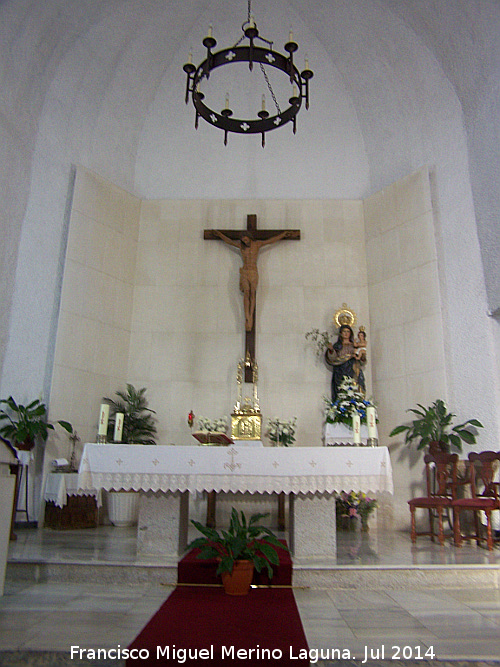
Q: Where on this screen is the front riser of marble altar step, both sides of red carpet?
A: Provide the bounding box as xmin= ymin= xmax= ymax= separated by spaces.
xmin=6 ymin=561 xmax=500 ymax=590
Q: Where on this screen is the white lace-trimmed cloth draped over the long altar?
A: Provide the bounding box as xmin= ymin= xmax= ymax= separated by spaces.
xmin=78 ymin=443 xmax=393 ymax=494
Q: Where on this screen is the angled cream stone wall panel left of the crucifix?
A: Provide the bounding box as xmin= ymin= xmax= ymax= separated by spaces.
xmin=45 ymin=168 xmax=140 ymax=467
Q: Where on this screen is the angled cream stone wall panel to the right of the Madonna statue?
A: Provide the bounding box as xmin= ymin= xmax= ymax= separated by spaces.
xmin=364 ymin=168 xmax=448 ymax=527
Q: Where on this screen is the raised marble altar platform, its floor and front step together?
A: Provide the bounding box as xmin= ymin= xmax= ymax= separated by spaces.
xmin=6 ymin=526 xmax=500 ymax=590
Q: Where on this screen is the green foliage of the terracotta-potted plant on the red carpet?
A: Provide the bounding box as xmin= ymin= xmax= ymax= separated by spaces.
xmin=188 ymin=507 xmax=288 ymax=578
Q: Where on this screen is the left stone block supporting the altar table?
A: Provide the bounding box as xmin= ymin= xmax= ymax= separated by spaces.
xmin=137 ymin=491 xmax=189 ymax=557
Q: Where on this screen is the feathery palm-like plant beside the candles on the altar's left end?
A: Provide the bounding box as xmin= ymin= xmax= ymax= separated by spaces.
xmin=105 ymin=383 xmax=156 ymax=445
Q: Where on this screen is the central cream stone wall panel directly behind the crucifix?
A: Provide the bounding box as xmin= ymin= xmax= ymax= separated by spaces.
xmin=129 ymin=200 xmax=370 ymax=445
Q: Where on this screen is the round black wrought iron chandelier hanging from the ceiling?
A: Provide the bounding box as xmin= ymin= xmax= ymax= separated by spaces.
xmin=183 ymin=0 xmax=313 ymax=147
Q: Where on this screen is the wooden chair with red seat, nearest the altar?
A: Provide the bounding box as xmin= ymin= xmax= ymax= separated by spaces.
xmin=408 ymin=452 xmax=458 ymax=544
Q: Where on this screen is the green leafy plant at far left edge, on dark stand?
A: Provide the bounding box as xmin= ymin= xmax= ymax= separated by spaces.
xmin=0 ymin=396 xmax=73 ymax=450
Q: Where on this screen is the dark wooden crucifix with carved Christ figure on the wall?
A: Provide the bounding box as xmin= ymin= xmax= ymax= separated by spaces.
xmin=203 ymin=214 xmax=300 ymax=382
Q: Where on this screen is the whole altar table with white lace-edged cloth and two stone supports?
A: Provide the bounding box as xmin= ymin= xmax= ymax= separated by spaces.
xmin=78 ymin=443 xmax=393 ymax=558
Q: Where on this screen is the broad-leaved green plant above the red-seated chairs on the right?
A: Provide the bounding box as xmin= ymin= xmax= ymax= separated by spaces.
xmin=389 ymin=399 xmax=483 ymax=452
